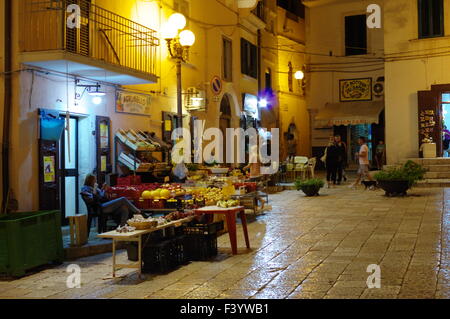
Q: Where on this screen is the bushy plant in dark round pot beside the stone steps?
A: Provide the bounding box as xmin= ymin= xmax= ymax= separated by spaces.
xmin=375 ymin=161 xmax=427 ymax=196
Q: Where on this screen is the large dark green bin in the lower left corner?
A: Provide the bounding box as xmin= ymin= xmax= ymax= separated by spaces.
xmin=0 ymin=211 xmax=64 ymax=277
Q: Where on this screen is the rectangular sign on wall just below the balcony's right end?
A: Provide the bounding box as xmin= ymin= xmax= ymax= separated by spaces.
xmin=116 ymin=90 xmax=152 ymax=116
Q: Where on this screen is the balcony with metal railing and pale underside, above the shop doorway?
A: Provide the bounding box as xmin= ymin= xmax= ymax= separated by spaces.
xmin=20 ymin=0 xmax=159 ymax=85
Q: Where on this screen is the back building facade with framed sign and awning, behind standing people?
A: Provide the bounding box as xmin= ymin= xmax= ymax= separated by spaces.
xmin=305 ymin=0 xmax=385 ymax=169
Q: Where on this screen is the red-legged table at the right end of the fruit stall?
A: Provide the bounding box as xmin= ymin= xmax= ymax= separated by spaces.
xmin=194 ymin=206 xmax=250 ymax=255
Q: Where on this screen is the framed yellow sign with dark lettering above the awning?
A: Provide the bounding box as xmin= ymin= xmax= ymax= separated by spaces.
xmin=339 ymin=78 xmax=372 ymax=102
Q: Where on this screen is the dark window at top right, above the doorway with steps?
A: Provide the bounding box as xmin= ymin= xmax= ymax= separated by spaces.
xmin=418 ymin=0 xmax=444 ymax=38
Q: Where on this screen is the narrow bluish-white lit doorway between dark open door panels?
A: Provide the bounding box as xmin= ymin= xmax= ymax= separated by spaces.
xmin=59 ymin=117 xmax=79 ymax=225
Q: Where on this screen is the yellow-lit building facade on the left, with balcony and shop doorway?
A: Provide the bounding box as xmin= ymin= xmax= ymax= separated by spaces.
xmin=0 ymin=0 xmax=310 ymax=216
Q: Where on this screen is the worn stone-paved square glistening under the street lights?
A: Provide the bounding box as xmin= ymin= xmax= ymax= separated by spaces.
xmin=0 ymin=186 xmax=450 ymax=299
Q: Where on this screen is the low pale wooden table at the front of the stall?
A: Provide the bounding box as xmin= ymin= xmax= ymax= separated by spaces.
xmin=98 ymin=217 xmax=194 ymax=278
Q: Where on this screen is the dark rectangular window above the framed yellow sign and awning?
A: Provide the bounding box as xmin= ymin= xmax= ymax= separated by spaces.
xmin=345 ymin=14 xmax=367 ymax=56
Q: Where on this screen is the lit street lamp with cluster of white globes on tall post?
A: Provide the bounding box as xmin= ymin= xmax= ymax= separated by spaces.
xmin=163 ymin=13 xmax=195 ymax=128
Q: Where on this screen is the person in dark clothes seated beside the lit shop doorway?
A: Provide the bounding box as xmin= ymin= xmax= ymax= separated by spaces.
xmin=81 ymin=174 xmax=141 ymax=230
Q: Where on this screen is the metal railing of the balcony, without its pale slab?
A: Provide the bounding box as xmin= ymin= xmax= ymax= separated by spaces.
xmin=20 ymin=0 xmax=159 ymax=79
